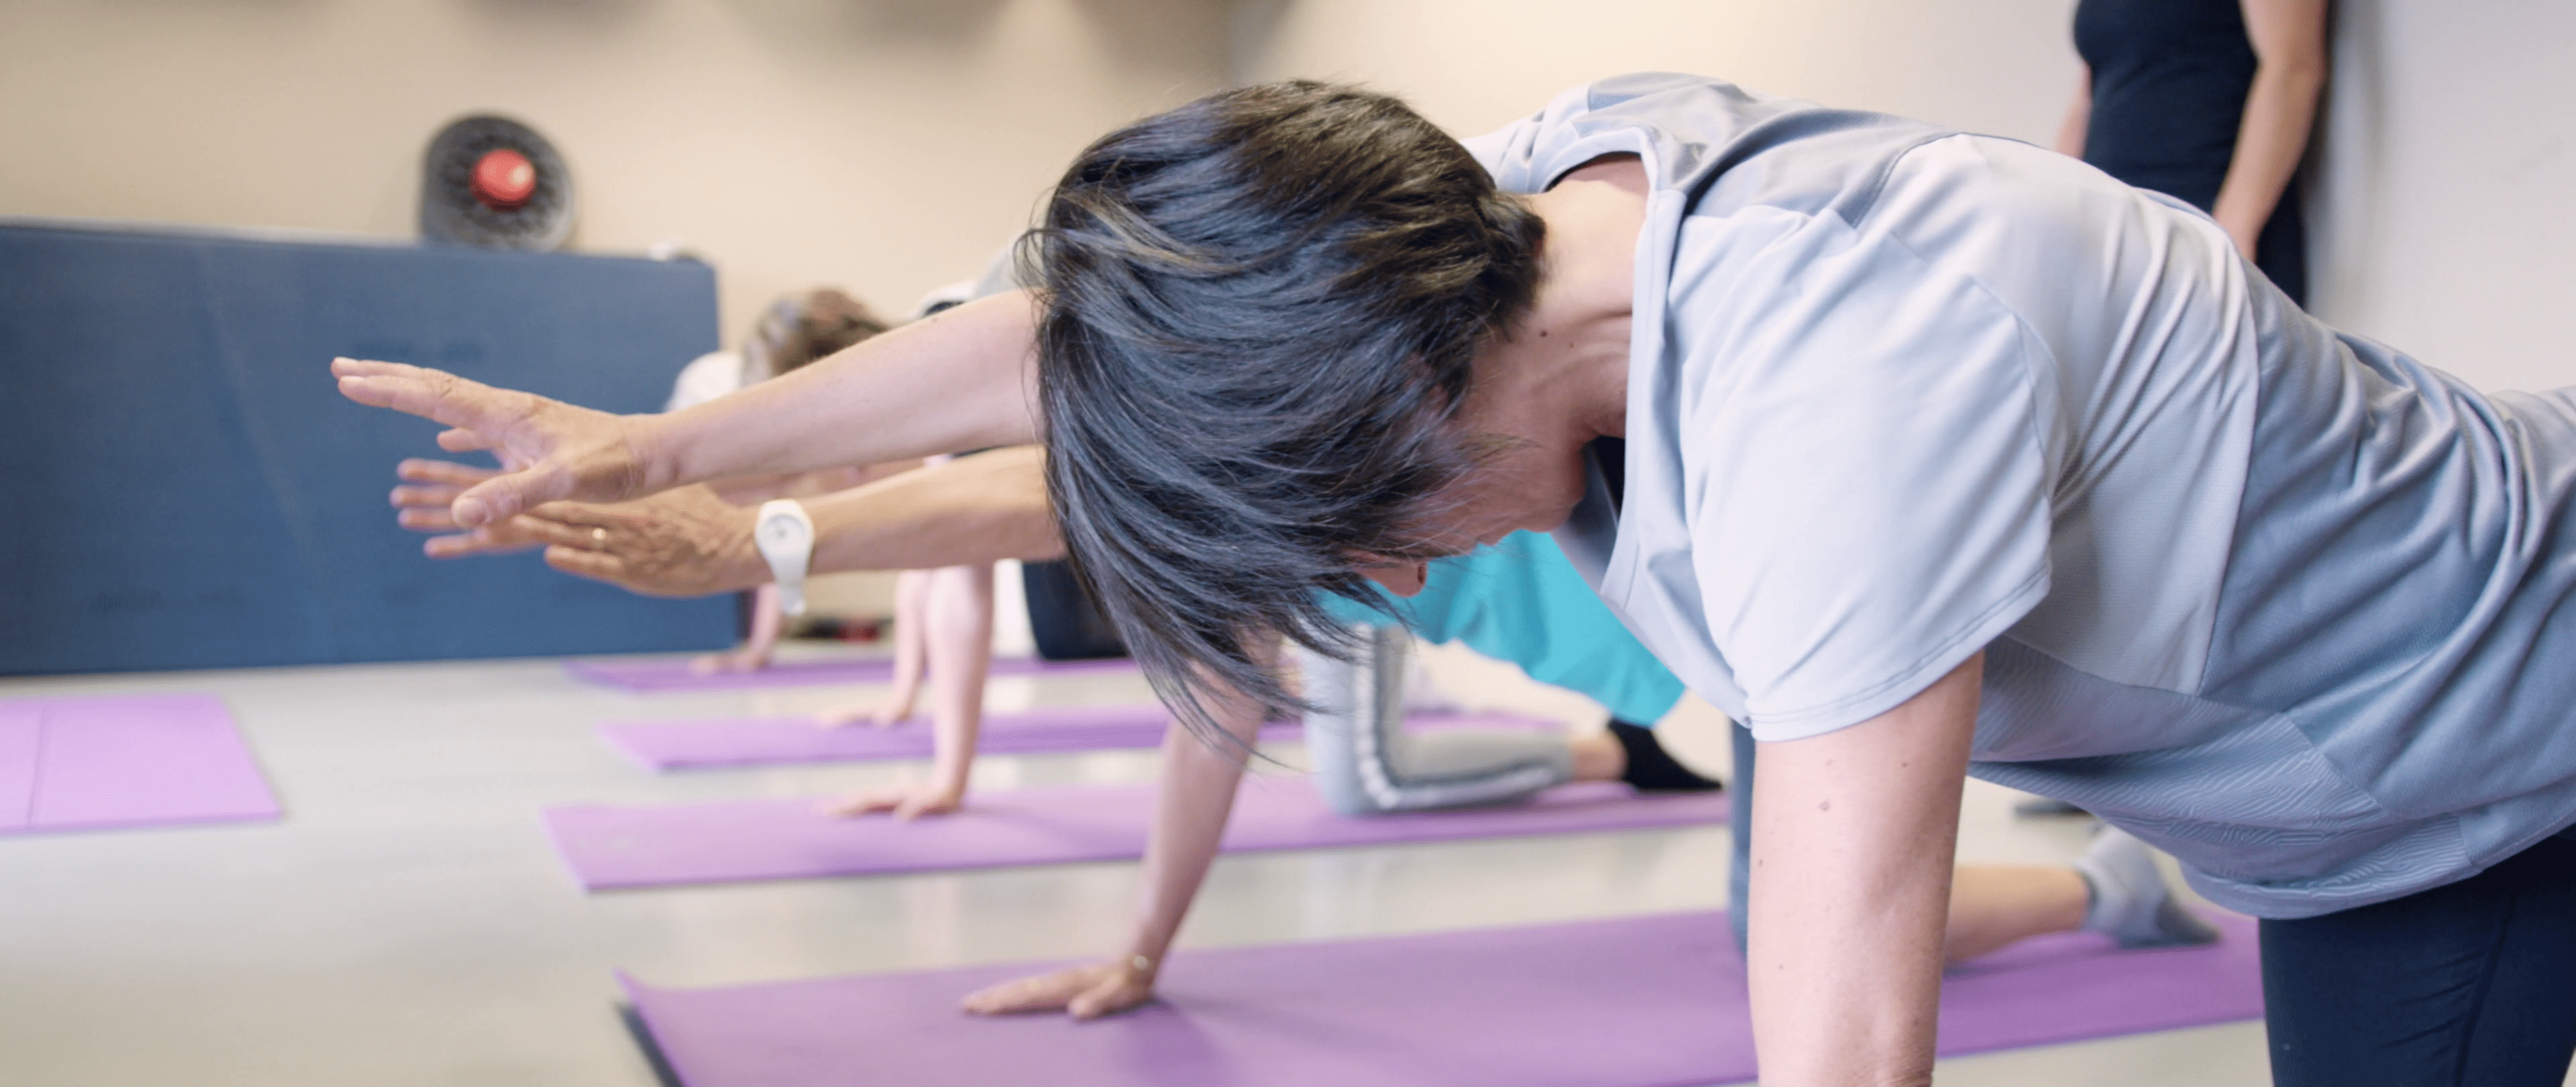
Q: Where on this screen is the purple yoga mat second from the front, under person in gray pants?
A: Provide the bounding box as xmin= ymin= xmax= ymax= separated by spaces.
xmin=546 ymin=778 xmax=1726 ymax=891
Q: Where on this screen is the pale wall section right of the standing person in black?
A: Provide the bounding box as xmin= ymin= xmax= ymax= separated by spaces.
xmin=2310 ymin=0 xmax=2576 ymax=389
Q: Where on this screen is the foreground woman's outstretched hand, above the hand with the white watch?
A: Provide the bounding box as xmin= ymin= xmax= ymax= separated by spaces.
xmin=330 ymin=358 xmax=649 ymax=531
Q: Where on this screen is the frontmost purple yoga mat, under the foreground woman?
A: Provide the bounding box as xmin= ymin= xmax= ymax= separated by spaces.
xmin=621 ymin=915 xmax=2262 ymax=1087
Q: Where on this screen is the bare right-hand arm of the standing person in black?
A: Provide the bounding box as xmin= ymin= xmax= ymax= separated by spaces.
xmin=2210 ymin=0 xmax=2326 ymax=260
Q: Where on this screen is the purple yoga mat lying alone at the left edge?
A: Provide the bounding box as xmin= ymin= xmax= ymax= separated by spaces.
xmin=0 ymin=695 xmax=278 ymax=835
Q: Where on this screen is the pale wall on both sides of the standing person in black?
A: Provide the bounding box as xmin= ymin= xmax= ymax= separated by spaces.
xmin=1234 ymin=0 xmax=2576 ymax=389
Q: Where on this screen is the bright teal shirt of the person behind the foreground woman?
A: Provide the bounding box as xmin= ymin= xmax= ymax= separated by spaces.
xmin=1324 ymin=533 xmax=1682 ymax=724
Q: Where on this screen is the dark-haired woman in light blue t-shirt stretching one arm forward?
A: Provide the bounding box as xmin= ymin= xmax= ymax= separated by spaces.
xmin=335 ymin=74 xmax=2576 ymax=1087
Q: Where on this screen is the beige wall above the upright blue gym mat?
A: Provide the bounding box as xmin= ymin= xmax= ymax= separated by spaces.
xmin=0 ymin=0 xmax=1226 ymax=343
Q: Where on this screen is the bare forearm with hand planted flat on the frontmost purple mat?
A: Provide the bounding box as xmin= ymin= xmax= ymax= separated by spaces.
xmin=966 ymin=659 xmax=1263 ymax=1020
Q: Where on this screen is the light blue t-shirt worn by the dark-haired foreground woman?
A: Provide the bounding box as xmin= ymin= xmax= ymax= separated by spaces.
xmin=1468 ymin=74 xmax=2576 ymax=917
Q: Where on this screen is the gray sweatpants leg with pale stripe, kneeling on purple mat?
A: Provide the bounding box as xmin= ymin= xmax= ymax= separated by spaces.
xmin=1301 ymin=626 xmax=1574 ymax=817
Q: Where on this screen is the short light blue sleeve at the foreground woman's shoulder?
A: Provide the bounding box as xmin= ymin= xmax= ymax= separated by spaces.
xmin=1669 ymin=219 xmax=2053 ymax=739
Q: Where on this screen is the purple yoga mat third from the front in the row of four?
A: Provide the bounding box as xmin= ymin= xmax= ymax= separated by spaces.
xmin=600 ymin=703 xmax=1554 ymax=770
